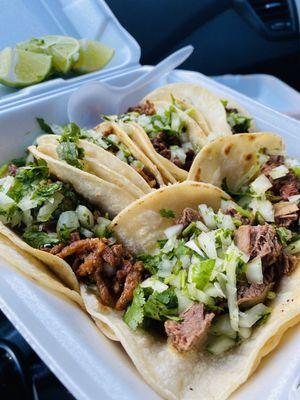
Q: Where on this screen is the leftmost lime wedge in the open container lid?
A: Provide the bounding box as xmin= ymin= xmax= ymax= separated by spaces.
xmin=0 ymin=47 xmax=51 ymax=87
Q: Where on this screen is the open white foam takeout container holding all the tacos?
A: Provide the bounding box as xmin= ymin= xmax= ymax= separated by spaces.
xmin=0 ymin=0 xmax=300 ymax=400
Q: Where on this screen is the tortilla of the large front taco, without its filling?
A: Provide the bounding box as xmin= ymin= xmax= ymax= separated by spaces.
xmin=81 ymin=182 xmax=300 ymax=400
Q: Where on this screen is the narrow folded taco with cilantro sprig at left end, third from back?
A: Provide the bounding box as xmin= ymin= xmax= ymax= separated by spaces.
xmin=37 ymin=120 xmax=164 ymax=191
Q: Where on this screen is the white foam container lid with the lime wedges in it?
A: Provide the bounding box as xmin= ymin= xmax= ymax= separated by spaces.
xmin=0 ymin=0 xmax=141 ymax=106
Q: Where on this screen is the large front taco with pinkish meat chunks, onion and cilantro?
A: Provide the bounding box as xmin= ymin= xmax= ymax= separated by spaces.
xmin=81 ymin=181 xmax=300 ymax=400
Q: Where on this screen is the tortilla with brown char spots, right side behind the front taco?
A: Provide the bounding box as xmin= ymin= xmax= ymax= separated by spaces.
xmin=188 ymin=132 xmax=284 ymax=191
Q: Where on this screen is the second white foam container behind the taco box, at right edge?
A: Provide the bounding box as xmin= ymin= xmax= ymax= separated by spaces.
xmin=213 ymin=74 xmax=300 ymax=119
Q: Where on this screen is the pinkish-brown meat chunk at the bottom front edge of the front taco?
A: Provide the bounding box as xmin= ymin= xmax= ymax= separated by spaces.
xmin=165 ymin=303 xmax=215 ymax=352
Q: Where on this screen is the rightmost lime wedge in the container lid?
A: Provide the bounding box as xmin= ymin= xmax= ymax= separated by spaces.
xmin=73 ymin=39 xmax=115 ymax=74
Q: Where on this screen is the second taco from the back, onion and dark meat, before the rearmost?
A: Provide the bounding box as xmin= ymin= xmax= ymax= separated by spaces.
xmin=111 ymin=101 xmax=207 ymax=183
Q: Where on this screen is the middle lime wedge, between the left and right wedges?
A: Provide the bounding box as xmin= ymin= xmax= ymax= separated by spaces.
xmin=17 ymin=35 xmax=80 ymax=74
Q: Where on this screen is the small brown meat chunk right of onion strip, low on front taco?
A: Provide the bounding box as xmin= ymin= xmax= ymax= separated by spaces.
xmin=237 ymin=282 xmax=274 ymax=309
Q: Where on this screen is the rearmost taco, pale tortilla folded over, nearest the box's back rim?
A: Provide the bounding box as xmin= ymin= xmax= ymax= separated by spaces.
xmin=143 ymin=82 xmax=254 ymax=141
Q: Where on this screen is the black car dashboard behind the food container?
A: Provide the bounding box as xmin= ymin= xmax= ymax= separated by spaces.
xmin=107 ymin=0 xmax=300 ymax=90
